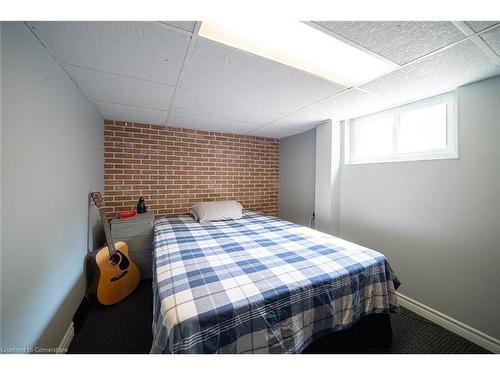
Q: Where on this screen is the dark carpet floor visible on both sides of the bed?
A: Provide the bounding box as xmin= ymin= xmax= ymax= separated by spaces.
xmin=69 ymin=280 xmax=489 ymax=354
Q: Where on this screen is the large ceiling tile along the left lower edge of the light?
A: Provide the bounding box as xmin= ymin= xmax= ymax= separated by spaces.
xmin=181 ymin=38 xmax=345 ymax=113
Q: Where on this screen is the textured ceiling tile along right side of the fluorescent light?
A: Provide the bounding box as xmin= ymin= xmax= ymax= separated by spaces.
xmin=315 ymin=21 xmax=465 ymax=65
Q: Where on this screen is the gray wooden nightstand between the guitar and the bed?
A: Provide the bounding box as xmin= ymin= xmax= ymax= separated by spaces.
xmin=111 ymin=211 xmax=155 ymax=279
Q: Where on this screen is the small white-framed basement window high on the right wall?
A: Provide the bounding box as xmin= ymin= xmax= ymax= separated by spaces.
xmin=344 ymin=92 xmax=458 ymax=164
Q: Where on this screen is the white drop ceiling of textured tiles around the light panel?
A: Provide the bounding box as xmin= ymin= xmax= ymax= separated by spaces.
xmin=28 ymin=21 xmax=500 ymax=138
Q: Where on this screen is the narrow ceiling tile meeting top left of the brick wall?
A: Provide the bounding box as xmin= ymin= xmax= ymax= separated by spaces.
xmin=96 ymin=102 xmax=167 ymax=125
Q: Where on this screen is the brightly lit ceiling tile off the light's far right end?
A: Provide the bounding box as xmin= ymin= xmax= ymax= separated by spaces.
xmin=304 ymin=89 xmax=391 ymax=121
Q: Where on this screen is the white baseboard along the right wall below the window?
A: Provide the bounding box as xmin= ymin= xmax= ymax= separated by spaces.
xmin=397 ymin=293 xmax=500 ymax=354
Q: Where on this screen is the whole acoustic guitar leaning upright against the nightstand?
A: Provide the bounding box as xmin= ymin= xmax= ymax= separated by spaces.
xmin=86 ymin=192 xmax=140 ymax=305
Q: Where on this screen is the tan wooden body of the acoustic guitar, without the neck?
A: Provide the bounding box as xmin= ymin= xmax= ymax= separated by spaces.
xmin=88 ymin=242 xmax=140 ymax=305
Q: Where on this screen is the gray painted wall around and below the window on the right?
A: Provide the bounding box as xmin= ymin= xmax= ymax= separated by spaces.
xmin=340 ymin=77 xmax=500 ymax=339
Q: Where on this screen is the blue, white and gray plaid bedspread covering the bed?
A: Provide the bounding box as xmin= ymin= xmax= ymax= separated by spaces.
xmin=151 ymin=213 xmax=399 ymax=353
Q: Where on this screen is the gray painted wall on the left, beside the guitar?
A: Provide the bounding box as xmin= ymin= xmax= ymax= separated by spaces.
xmin=1 ymin=22 xmax=104 ymax=347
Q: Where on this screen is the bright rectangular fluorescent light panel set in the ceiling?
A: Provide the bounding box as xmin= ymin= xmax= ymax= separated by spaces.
xmin=199 ymin=20 xmax=398 ymax=87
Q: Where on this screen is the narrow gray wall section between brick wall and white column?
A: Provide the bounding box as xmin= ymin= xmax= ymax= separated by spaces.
xmin=279 ymin=129 xmax=316 ymax=226
